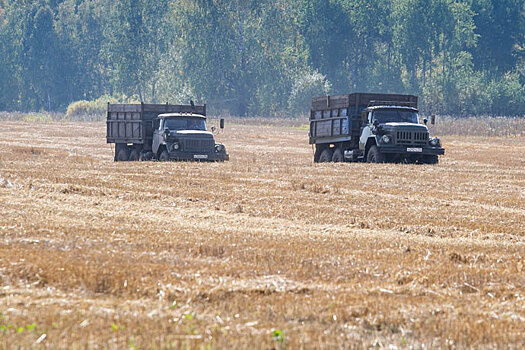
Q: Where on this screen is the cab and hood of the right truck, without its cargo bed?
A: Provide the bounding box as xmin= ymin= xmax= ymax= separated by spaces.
xmin=359 ymin=105 xmax=445 ymax=164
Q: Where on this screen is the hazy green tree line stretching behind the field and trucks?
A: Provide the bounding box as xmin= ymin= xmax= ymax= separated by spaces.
xmin=0 ymin=0 xmax=525 ymax=116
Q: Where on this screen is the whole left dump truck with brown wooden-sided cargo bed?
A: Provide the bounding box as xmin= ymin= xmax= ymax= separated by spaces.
xmin=106 ymin=103 xmax=229 ymax=161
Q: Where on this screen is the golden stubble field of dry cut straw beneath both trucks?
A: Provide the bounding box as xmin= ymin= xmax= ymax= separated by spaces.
xmin=0 ymin=121 xmax=525 ymax=349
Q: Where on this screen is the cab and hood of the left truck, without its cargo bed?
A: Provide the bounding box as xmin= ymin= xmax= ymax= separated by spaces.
xmin=152 ymin=113 xmax=229 ymax=161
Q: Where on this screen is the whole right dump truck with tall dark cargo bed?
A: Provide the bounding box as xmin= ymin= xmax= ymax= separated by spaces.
xmin=309 ymin=93 xmax=445 ymax=164
